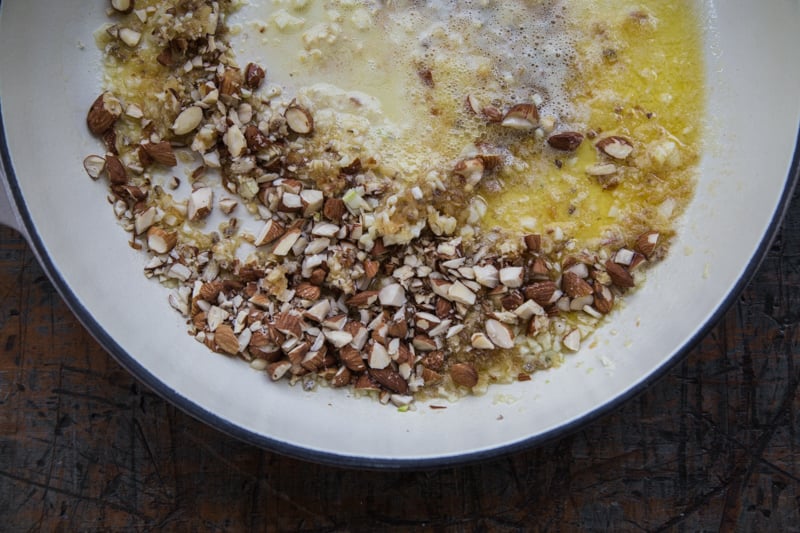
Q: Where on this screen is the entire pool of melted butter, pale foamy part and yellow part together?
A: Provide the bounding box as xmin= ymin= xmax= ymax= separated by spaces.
xmin=232 ymin=0 xmax=703 ymax=247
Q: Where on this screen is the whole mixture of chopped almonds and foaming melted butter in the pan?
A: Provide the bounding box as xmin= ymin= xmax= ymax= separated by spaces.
xmin=84 ymin=0 xmax=703 ymax=409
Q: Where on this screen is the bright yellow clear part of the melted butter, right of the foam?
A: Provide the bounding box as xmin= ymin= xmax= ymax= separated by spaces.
xmin=485 ymin=0 xmax=703 ymax=244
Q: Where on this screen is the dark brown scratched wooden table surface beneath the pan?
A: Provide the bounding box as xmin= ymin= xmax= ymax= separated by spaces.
xmin=0 ymin=190 xmax=800 ymax=532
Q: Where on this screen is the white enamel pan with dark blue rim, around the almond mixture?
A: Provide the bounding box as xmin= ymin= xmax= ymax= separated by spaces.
xmin=0 ymin=0 xmax=800 ymax=468
